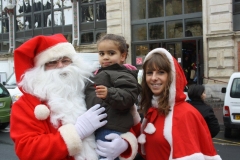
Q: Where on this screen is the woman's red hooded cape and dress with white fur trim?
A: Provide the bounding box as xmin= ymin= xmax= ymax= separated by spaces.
xmin=123 ymin=48 xmax=221 ymax=160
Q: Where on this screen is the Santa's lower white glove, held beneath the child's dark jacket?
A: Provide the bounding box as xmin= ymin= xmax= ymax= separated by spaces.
xmin=96 ymin=133 xmax=128 ymax=160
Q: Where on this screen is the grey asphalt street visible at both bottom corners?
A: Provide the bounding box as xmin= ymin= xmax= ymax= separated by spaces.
xmin=0 ymin=126 xmax=240 ymax=160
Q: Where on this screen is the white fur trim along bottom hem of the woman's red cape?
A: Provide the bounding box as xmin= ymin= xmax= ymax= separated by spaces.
xmin=172 ymin=153 xmax=222 ymax=160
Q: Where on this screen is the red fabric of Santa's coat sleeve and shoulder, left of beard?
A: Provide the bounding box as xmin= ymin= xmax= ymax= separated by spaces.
xmin=10 ymin=94 xmax=73 ymax=160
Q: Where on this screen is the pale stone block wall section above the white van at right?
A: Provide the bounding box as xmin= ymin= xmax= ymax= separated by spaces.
xmin=203 ymin=0 xmax=234 ymax=100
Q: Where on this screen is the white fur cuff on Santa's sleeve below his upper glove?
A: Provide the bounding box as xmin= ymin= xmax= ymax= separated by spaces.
xmin=58 ymin=124 xmax=82 ymax=156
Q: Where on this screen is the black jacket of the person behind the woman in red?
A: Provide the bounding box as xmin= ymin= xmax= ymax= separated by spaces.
xmin=188 ymin=100 xmax=220 ymax=138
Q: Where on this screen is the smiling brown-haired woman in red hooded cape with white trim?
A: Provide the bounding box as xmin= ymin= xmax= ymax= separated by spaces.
xmin=95 ymin=48 xmax=221 ymax=160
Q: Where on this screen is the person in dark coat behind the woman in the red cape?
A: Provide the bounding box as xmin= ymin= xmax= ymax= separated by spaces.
xmin=188 ymin=84 xmax=220 ymax=138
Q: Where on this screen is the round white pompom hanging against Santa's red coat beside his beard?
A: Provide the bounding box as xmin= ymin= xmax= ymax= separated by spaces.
xmin=34 ymin=104 xmax=50 ymax=120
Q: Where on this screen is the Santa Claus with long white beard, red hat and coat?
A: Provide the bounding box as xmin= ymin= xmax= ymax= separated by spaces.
xmin=10 ymin=34 xmax=107 ymax=160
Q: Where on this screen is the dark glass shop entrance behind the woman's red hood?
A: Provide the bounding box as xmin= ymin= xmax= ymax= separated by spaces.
xmin=133 ymin=39 xmax=203 ymax=84
